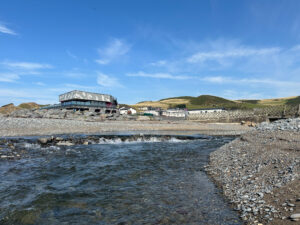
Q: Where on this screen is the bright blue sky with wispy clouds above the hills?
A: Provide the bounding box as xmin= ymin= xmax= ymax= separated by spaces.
xmin=0 ymin=0 xmax=300 ymax=105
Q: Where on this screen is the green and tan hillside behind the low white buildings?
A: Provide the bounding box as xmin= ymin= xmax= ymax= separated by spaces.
xmin=135 ymin=95 xmax=300 ymax=109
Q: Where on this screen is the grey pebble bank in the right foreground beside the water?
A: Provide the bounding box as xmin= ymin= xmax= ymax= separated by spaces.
xmin=206 ymin=119 xmax=300 ymax=225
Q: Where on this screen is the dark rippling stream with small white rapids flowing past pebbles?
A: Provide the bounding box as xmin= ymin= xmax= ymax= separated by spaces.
xmin=0 ymin=136 xmax=241 ymax=225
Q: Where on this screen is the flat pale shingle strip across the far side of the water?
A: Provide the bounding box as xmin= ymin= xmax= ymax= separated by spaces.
xmin=0 ymin=117 xmax=251 ymax=137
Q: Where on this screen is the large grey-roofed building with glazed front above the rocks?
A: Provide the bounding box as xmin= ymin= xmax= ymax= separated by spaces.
xmin=44 ymin=90 xmax=118 ymax=113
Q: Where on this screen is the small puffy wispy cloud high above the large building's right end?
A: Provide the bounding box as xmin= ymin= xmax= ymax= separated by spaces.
xmin=96 ymin=38 xmax=130 ymax=65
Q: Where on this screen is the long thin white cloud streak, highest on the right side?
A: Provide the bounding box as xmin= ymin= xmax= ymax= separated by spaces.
xmin=187 ymin=47 xmax=280 ymax=63
